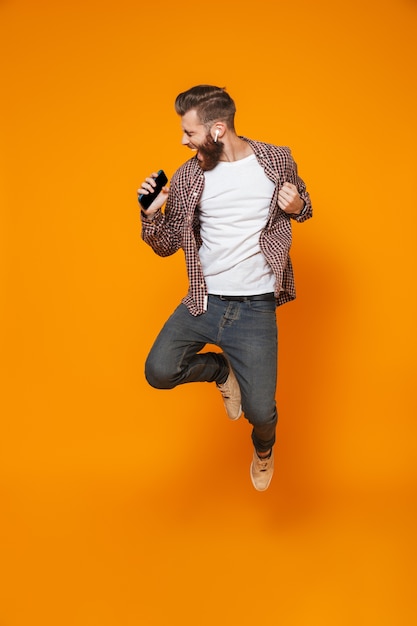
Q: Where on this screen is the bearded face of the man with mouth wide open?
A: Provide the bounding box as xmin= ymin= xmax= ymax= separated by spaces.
xmin=181 ymin=109 xmax=223 ymax=171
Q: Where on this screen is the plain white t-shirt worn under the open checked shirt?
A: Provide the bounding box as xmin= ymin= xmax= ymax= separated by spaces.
xmin=199 ymin=154 xmax=275 ymax=296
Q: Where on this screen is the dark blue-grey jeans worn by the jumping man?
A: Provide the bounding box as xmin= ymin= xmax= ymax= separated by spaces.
xmin=145 ymin=295 xmax=278 ymax=452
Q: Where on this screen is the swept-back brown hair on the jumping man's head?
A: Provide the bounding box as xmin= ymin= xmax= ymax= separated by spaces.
xmin=175 ymin=85 xmax=236 ymax=130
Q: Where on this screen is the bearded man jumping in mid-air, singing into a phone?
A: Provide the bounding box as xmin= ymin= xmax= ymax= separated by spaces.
xmin=138 ymin=85 xmax=312 ymax=491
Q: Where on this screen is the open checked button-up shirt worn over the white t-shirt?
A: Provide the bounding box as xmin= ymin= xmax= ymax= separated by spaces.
xmin=142 ymin=137 xmax=312 ymax=315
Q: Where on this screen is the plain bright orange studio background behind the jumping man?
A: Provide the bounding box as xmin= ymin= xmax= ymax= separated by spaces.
xmin=0 ymin=0 xmax=417 ymax=626
